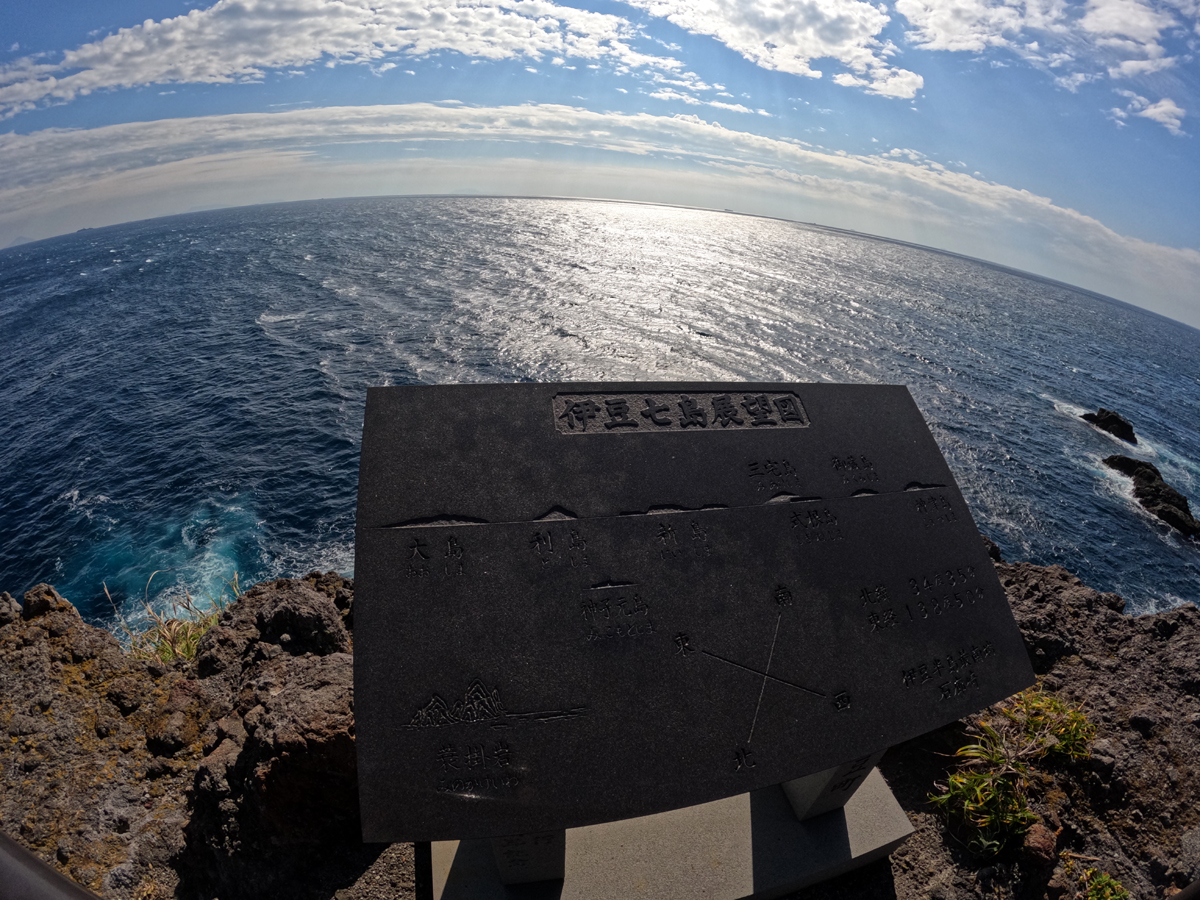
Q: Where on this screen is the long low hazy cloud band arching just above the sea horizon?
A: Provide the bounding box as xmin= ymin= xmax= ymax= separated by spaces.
xmin=0 ymin=102 xmax=1200 ymax=325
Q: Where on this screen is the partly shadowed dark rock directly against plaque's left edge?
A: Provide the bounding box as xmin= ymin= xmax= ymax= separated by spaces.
xmin=187 ymin=580 xmax=360 ymax=896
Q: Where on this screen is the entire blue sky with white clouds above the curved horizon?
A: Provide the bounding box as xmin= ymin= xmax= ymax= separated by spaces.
xmin=0 ymin=0 xmax=1200 ymax=328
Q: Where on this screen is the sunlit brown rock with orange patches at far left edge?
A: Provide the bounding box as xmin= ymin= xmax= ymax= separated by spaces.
xmin=0 ymin=584 xmax=196 ymax=898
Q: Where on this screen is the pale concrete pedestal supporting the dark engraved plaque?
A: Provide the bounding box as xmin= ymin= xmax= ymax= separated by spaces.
xmin=416 ymin=769 xmax=913 ymax=900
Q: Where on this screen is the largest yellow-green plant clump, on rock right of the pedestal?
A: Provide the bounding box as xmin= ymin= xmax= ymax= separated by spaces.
xmin=930 ymin=684 xmax=1096 ymax=859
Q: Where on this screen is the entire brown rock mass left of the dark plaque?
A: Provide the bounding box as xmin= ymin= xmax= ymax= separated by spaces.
xmin=0 ymin=572 xmax=367 ymax=900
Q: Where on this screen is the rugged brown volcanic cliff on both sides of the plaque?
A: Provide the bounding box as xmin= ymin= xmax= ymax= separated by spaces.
xmin=0 ymin=564 xmax=1200 ymax=900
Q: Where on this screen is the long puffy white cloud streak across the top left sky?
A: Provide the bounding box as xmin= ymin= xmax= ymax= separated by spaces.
xmin=0 ymin=0 xmax=682 ymax=115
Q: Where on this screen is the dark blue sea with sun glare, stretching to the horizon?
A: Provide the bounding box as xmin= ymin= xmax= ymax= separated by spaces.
xmin=0 ymin=198 xmax=1200 ymax=622
